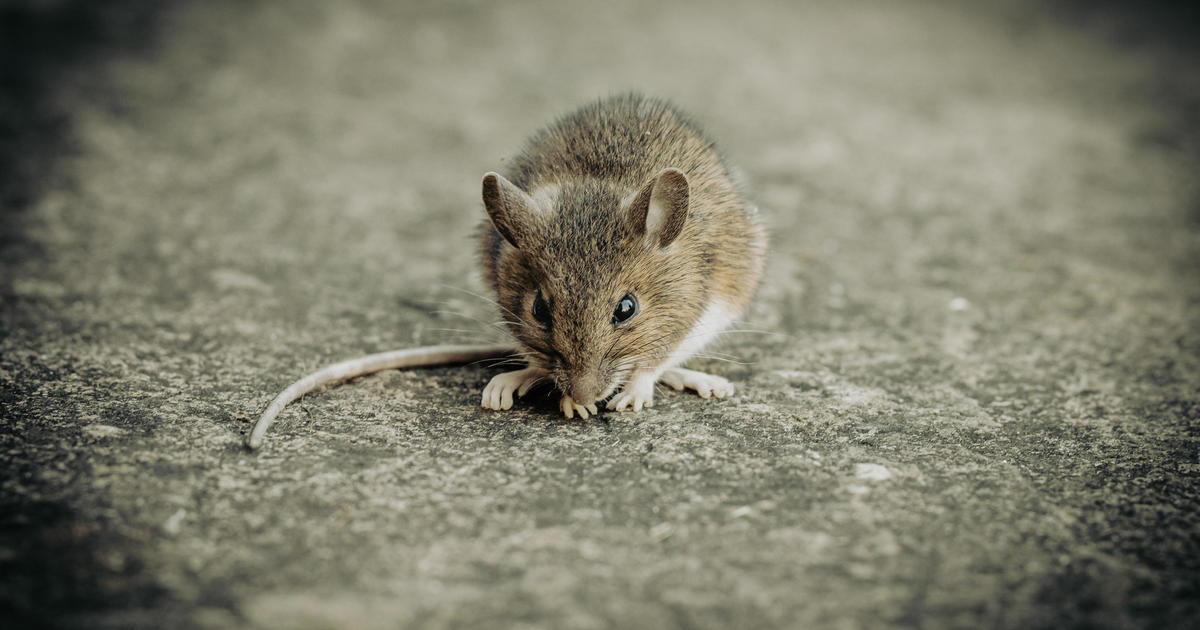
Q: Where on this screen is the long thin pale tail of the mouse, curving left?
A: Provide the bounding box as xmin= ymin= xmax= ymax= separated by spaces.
xmin=246 ymin=346 xmax=516 ymax=450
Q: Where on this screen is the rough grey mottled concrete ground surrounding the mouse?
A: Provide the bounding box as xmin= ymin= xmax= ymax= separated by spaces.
xmin=0 ymin=0 xmax=1200 ymax=629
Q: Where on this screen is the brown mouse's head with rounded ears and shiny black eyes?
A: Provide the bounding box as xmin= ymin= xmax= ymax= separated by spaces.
xmin=484 ymin=168 xmax=706 ymax=404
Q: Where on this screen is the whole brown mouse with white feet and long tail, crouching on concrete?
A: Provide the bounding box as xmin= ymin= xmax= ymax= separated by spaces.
xmin=246 ymin=92 xmax=767 ymax=450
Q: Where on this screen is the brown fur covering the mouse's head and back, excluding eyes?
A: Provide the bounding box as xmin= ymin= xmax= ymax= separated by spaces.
xmin=481 ymin=95 xmax=766 ymax=400
